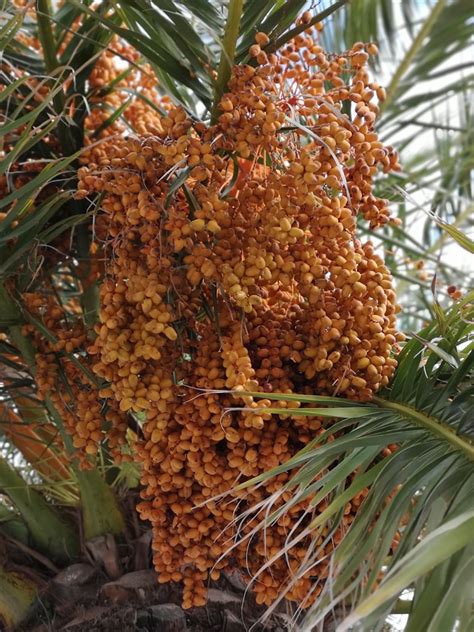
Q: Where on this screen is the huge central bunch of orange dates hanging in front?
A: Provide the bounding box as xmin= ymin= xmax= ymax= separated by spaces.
xmin=77 ymin=22 xmax=400 ymax=607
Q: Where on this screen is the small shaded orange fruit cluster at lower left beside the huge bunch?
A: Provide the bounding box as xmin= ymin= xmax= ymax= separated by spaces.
xmin=23 ymin=293 xmax=129 ymax=469
